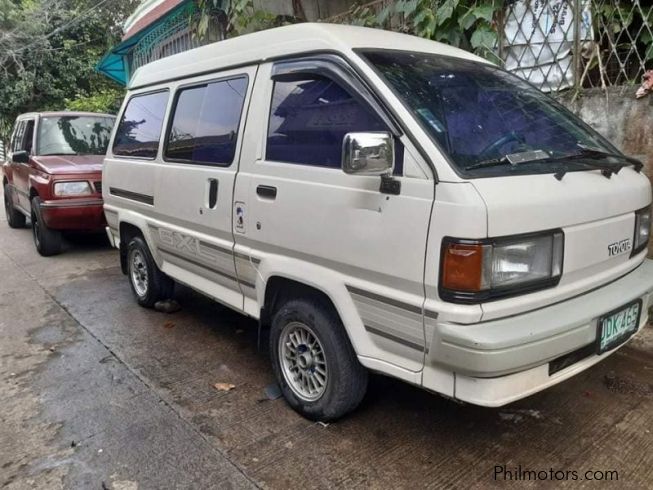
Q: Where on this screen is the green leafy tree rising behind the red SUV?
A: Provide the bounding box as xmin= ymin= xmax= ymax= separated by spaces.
xmin=0 ymin=0 xmax=138 ymax=145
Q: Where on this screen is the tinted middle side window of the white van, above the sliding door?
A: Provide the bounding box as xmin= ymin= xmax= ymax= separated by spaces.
xmin=165 ymin=78 xmax=247 ymax=166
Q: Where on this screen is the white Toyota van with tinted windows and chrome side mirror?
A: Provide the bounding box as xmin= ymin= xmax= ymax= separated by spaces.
xmin=103 ymin=24 xmax=653 ymax=420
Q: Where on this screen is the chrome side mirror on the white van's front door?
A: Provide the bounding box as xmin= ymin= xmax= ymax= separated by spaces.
xmin=342 ymin=132 xmax=395 ymax=175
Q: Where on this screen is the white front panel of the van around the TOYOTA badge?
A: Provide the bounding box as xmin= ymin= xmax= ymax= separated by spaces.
xmin=472 ymin=167 xmax=651 ymax=320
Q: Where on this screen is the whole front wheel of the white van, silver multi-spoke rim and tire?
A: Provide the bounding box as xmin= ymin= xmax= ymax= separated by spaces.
xmin=270 ymin=299 xmax=367 ymax=421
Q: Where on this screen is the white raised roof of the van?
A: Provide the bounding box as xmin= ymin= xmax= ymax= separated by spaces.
xmin=129 ymin=22 xmax=488 ymax=89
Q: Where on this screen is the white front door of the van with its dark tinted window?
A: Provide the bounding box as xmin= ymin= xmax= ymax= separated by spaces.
xmin=235 ymin=56 xmax=435 ymax=371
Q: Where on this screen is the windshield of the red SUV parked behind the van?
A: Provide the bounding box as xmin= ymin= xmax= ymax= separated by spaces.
xmin=37 ymin=115 xmax=114 ymax=155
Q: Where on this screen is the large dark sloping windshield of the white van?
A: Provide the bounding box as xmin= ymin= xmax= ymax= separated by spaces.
xmin=361 ymin=50 xmax=618 ymax=177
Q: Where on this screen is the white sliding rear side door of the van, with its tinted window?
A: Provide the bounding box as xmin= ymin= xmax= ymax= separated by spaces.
xmin=151 ymin=68 xmax=255 ymax=310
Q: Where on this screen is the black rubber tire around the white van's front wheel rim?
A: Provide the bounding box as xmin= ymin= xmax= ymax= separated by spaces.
xmin=270 ymin=298 xmax=368 ymax=422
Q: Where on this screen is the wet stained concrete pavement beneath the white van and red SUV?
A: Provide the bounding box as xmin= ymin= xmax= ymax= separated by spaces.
xmin=0 ymin=186 xmax=653 ymax=490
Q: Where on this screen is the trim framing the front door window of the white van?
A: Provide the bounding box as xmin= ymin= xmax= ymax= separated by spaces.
xmin=262 ymin=53 xmax=402 ymax=173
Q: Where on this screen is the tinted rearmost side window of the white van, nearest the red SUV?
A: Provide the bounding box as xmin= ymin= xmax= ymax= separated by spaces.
xmin=113 ymin=90 xmax=168 ymax=158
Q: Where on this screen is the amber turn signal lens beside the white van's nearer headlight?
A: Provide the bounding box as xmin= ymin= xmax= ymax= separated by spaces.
xmin=442 ymin=243 xmax=484 ymax=291
